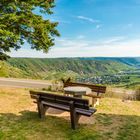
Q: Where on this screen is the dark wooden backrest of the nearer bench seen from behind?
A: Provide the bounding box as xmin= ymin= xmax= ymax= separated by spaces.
xmin=30 ymin=91 xmax=89 ymax=110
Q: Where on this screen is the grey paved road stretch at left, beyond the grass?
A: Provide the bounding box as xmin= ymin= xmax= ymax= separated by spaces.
xmin=0 ymin=78 xmax=51 ymax=88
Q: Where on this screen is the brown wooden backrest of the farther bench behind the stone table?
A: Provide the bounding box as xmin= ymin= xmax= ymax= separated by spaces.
xmin=64 ymin=82 xmax=106 ymax=93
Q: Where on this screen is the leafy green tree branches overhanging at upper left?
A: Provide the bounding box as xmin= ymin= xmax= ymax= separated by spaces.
xmin=0 ymin=0 xmax=59 ymax=58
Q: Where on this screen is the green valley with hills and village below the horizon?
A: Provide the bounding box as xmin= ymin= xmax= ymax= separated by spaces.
xmin=0 ymin=57 xmax=140 ymax=88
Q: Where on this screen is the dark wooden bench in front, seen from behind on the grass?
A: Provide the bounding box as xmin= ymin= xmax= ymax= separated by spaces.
xmin=30 ymin=91 xmax=96 ymax=129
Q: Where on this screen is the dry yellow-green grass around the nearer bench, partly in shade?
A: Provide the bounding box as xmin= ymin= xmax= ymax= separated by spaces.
xmin=0 ymin=88 xmax=140 ymax=140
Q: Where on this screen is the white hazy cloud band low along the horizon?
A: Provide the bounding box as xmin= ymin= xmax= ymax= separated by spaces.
xmin=7 ymin=37 xmax=140 ymax=58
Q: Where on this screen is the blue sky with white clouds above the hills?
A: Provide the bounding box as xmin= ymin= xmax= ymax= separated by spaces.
xmin=10 ymin=0 xmax=140 ymax=58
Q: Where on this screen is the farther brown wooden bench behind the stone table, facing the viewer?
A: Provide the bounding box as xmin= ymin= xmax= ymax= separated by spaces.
xmin=62 ymin=78 xmax=106 ymax=107
